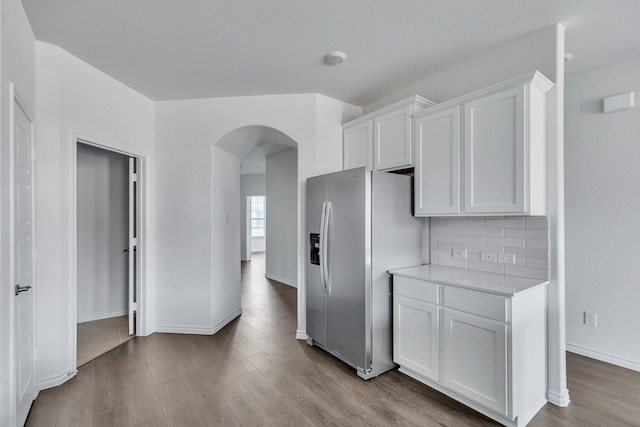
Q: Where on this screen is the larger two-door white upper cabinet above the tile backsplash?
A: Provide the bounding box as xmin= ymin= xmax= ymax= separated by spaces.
xmin=413 ymin=71 xmax=552 ymax=216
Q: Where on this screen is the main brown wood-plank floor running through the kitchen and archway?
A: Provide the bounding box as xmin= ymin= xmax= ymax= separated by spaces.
xmin=27 ymin=255 xmax=640 ymax=427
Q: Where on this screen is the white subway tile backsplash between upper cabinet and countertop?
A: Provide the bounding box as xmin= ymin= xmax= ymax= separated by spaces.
xmin=430 ymin=217 xmax=549 ymax=279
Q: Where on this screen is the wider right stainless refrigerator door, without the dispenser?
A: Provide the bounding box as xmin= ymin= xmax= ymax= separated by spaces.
xmin=326 ymin=168 xmax=371 ymax=370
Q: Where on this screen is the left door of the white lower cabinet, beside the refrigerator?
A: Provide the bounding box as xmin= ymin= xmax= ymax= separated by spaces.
xmin=393 ymin=295 xmax=440 ymax=381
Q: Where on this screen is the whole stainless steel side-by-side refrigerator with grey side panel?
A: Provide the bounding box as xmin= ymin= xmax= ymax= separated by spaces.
xmin=305 ymin=168 xmax=424 ymax=379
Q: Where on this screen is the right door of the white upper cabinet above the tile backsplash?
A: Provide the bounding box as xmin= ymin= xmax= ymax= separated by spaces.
xmin=464 ymin=85 xmax=528 ymax=213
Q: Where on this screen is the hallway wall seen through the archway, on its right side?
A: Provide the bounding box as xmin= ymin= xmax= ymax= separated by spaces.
xmin=265 ymin=149 xmax=298 ymax=287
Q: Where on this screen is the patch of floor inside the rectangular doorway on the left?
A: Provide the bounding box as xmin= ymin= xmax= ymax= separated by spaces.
xmin=77 ymin=315 xmax=133 ymax=366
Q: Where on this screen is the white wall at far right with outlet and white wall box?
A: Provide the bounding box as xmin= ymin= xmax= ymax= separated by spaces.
xmin=565 ymin=58 xmax=640 ymax=370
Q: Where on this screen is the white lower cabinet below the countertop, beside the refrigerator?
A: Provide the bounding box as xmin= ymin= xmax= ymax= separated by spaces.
xmin=393 ymin=275 xmax=547 ymax=426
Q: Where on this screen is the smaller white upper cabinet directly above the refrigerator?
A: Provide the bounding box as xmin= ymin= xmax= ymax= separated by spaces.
xmin=342 ymin=96 xmax=434 ymax=170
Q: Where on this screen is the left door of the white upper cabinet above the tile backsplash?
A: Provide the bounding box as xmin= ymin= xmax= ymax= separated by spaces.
xmin=413 ymin=106 xmax=460 ymax=216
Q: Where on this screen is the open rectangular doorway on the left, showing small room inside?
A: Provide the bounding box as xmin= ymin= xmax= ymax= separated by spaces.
xmin=75 ymin=139 xmax=141 ymax=367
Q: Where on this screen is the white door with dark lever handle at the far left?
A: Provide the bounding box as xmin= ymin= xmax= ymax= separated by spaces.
xmin=13 ymin=93 xmax=35 ymax=425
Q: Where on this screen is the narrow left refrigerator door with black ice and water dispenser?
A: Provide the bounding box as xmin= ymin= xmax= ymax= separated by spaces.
xmin=305 ymin=176 xmax=327 ymax=348
